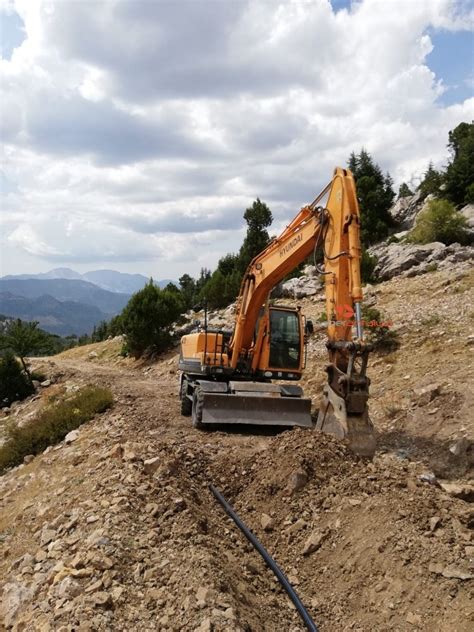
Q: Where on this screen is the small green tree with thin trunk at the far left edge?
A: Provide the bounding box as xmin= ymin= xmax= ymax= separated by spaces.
xmin=0 ymin=318 xmax=51 ymax=382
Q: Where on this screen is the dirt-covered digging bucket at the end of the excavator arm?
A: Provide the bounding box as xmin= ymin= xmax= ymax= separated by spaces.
xmin=316 ymin=386 xmax=376 ymax=458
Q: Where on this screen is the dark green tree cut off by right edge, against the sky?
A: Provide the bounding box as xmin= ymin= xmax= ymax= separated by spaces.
xmin=444 ymin=123 xmax=474 ymax=206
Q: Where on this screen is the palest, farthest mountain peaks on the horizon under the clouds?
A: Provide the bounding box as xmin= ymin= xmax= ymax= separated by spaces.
xmin=1 ymin=268 xmax=170 ymax=294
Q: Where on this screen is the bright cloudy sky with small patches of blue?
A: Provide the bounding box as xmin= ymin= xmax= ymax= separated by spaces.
xmin=0 ymin=0 xmax=474 ymax=279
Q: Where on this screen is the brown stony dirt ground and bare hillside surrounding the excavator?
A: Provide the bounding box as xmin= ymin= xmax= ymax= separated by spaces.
xmin=0 ymin=270 xmax=474 ymax=632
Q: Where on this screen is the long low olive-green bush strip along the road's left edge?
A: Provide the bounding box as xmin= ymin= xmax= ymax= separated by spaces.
xmin=0 ymin=385 xmax=113 ymax=472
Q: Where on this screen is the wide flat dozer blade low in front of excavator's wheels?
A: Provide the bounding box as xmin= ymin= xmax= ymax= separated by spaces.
xmin=202 ymin=393 xmax=313 ymax=428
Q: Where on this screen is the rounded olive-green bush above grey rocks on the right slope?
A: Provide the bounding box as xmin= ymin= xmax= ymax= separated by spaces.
xmin=408 ymin=200 xmax=468 ymax=246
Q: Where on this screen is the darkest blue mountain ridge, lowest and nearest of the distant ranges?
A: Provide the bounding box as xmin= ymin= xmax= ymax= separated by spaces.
xmin=0 ymin=292 xmax=110 ymax=336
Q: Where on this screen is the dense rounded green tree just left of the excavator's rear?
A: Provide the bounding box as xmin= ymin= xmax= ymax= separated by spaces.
xmin=122 ymin=279 xmax=184 ymax=358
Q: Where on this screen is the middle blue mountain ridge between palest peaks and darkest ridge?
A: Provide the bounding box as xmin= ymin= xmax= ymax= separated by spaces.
xmin=0 ymin=279 xmax=130 ymax=315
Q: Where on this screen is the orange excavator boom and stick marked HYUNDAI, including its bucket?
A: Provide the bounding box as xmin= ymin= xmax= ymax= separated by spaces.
xmin=229 ymin=168 xmax=375 ymax=456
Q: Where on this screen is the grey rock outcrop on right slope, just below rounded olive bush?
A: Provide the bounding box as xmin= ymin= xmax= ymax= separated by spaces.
xmin=369 ymin=242 xmax=474 ymax=281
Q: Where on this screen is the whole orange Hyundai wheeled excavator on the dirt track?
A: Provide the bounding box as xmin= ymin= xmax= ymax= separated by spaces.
xmin=178 ymin=167 xmax=375 ymax=457
